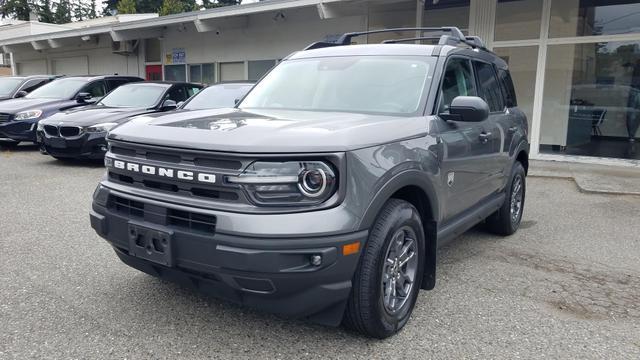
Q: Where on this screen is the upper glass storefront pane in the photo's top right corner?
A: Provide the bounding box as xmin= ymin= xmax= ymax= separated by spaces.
xmin=549 ymin=0 xmax=640 ymax=37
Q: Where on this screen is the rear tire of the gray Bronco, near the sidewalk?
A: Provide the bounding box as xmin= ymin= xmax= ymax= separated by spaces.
xmin=487 ymin=161 xmax=526 ymax=236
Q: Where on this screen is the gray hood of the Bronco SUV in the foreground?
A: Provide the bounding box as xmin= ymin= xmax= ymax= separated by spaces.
xmin=109 ymin=109 xmax=428 ymax=153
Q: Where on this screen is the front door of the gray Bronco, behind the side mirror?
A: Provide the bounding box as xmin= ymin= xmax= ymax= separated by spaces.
xmin=438 ymin=56 xmax=492 ymax=220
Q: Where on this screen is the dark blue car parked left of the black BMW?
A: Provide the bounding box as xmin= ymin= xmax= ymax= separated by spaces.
xmin=0 ymin=75 xmax=143 ymax=145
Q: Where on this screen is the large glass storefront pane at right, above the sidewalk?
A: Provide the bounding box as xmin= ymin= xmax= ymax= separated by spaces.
xmin=540 ymin=41 xmax=640 ymax=159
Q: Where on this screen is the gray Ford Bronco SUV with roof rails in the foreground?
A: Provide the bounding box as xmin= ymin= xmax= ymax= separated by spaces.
xmin=91 ymin=28 xmax=529 ymax=338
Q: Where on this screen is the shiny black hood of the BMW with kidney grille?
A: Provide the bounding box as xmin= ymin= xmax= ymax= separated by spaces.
xmin=42 ymin=105 xmax=152 ymax=126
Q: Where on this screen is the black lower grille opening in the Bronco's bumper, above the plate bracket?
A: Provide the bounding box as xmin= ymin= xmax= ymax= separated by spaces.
xmin=107 ymin=195 xmax=217 ymax=234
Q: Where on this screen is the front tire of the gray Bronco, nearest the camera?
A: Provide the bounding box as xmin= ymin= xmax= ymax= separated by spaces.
xmin=343 ymin=199 xmax=425 ymax=339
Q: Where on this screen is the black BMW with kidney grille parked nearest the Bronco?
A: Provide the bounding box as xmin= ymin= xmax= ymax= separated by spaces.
xmin=37 ymin=82 xmax=203 ymax=159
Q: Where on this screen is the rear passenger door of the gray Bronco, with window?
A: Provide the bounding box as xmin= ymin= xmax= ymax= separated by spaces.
xmin=473 ymin=60 xmax=509 ymax=196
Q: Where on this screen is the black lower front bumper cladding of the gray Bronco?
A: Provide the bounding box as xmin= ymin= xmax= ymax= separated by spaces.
xmin=91 ymin=195 xmax=367 ymax=326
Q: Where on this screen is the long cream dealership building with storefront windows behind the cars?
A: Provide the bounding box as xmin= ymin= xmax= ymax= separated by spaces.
xmin=0 ymin=0 xmax=640 ymax=166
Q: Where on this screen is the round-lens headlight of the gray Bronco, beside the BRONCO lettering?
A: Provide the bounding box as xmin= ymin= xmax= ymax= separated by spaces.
xmin=227 ymin=161 xmax=338 ymax=206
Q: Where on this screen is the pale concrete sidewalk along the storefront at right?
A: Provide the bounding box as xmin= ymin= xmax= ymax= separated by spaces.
xmin=529 ymin=160 xmax=640 ymax=196
